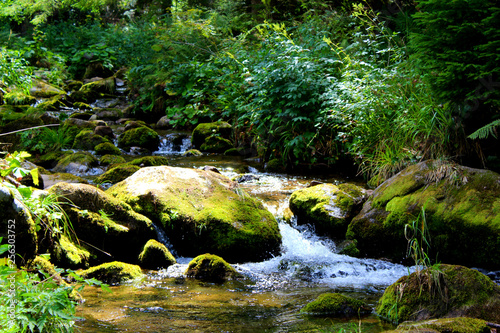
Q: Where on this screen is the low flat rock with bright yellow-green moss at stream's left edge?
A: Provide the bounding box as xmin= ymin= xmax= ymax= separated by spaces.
xmin=78 ymin=261 xmax=143 ymax=285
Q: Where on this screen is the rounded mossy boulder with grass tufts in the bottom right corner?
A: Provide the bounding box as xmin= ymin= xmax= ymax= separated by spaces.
xmin=376 ymin=264 xmax=500 ymax=322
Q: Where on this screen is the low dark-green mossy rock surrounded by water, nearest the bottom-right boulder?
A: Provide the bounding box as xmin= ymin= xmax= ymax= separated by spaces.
xmin=300 ymin=293 xmax=372 ymax=317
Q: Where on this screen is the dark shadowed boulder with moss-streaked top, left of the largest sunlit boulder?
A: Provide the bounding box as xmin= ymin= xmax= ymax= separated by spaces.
xmin=49 ymin=183 xmax=156 ymax=263
